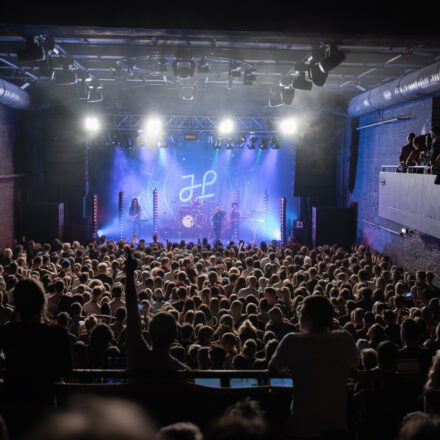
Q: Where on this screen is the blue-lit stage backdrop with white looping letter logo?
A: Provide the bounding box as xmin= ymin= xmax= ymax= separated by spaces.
xmin=96 ymin=138 xmax=296 ymax=241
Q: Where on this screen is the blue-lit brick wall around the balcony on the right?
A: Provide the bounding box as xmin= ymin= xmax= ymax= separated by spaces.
xmin=340 ymin=98 xmax=440 ymax=278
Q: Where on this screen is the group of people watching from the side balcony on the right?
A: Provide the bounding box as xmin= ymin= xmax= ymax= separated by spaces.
xmin=398 ymin=126 xmax=440 ymax=175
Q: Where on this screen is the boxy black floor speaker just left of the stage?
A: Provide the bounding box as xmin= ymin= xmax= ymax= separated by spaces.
xmin=24 ymin=203 xmax=64 ymax=243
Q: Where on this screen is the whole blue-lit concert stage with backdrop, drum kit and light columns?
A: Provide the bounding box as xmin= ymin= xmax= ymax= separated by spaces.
xmin=91 ymin=120 xmax=296 ymax=243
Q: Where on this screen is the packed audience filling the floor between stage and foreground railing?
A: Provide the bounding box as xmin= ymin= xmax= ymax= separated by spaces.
xmin=0 ymin=237 xmax=440 ymax=439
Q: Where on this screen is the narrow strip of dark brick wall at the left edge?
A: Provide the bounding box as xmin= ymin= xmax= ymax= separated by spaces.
xmin=0 ymin=104 xmax=15 ymax=250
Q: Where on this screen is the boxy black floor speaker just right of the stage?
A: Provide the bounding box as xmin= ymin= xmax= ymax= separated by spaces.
xmin=312 ymin=206 xmax=356 ymax=250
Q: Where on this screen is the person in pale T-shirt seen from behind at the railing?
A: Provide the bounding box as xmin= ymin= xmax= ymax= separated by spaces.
xmin=269 ymin=295 xmax=359 ymax=438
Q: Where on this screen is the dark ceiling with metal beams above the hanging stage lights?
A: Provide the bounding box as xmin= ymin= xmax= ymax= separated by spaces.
xmin=0 ymin=2 xmax=440 ymax=109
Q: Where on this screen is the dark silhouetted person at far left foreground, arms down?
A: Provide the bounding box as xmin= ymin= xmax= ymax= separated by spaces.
xmin=0 ymin=279 xmax=72 ymax=433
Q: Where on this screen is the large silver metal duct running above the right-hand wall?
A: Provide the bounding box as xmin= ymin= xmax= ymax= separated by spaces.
xmin=348 ymin=61 xmax=440 ymax=117
